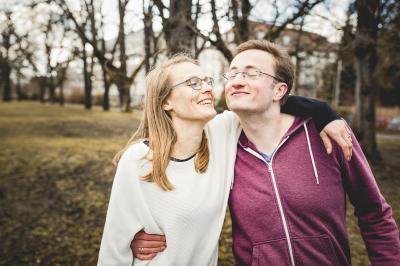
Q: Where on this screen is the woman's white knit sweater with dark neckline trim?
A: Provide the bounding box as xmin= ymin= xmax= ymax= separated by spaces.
xmin=98 ymin=112 xmax=240 ymax=266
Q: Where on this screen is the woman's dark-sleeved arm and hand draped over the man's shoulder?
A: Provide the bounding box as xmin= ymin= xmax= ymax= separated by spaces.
xmin=282 ymin=96 xmax=352 ymax=160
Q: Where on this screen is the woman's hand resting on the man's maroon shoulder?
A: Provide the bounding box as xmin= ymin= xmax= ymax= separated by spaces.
xmin=319 ymin=119 xmax=353 ymax=161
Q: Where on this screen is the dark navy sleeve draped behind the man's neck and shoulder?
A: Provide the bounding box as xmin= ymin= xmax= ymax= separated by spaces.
xmin=282 ymin=95 xmax=340 ymax=132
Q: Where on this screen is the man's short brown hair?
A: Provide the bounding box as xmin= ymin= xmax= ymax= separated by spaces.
xmin=234 ymin=40 xmax=296 ymax=104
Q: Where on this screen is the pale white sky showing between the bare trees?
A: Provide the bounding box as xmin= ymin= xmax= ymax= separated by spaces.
xmin=0 ymin=0 xmax=350 ymax=77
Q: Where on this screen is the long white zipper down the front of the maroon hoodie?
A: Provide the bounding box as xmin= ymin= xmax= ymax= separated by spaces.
xmin=239 ymin=136 xmax=295 ymax=266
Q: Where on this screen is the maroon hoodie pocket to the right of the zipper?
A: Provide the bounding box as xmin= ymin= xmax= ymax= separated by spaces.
xmin=292 ymin=235 xmax=340 ymax=266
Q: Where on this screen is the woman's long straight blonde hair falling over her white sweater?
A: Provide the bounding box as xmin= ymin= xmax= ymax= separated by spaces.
xmin=113 ymin=54 xmax=210 ymax=191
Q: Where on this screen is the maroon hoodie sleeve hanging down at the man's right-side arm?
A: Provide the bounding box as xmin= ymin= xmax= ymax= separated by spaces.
xmin=339 ymin=135 xmax=400 ymax=266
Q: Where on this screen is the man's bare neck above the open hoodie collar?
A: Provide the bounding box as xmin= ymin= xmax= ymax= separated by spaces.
xmin=238 ymin=107 xmax=294 ymax=155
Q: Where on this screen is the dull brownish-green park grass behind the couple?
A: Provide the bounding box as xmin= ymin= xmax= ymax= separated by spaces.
xmin=0 ymin=102 xmax=400 ymax=265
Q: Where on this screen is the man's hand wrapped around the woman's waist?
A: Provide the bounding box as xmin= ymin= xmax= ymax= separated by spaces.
xmin=131 ymin=231 xmax=167 ymax=260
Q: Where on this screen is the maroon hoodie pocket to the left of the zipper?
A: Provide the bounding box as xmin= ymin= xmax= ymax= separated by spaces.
xmin=251 ymin=238 xmax=290 ymax=266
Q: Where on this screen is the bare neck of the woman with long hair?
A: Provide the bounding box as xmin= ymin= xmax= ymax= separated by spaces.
xmin=171 ymin=119 xmax=205 ymax=159
